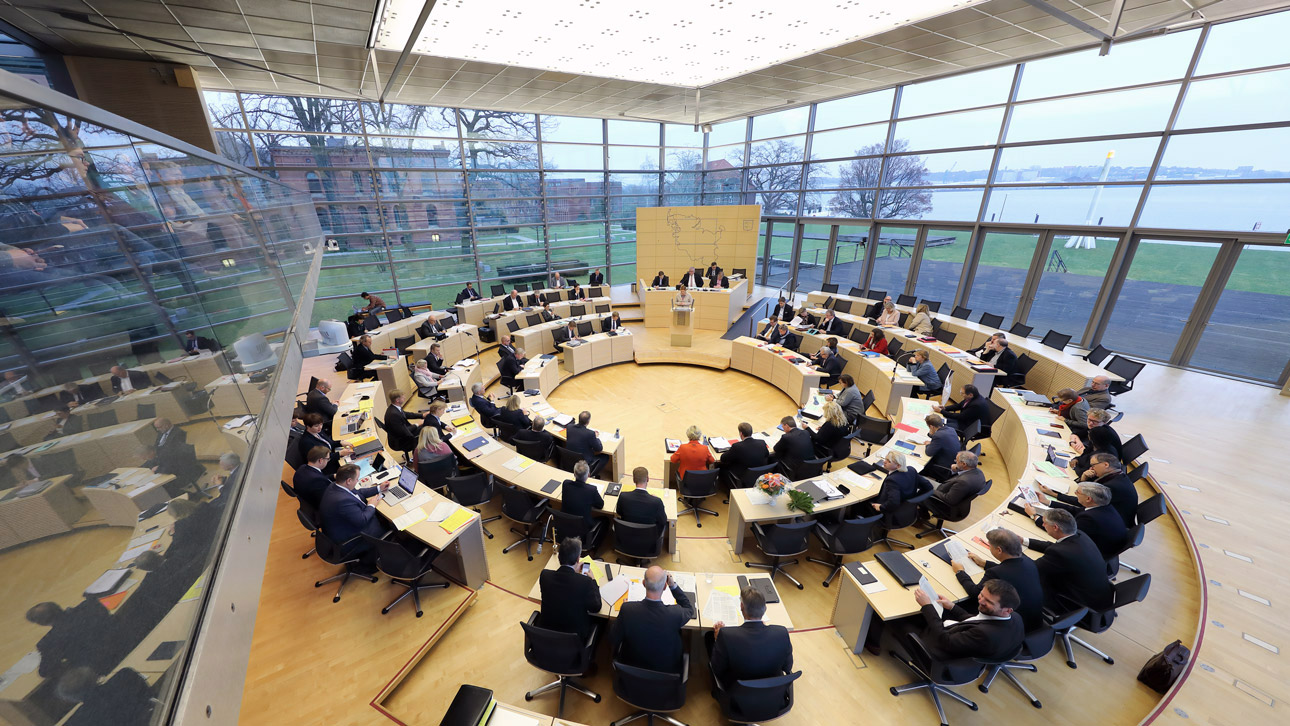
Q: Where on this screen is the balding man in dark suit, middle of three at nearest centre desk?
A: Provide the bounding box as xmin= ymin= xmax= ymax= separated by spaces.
xmin=610 ymin=565 xmax=694 ymax=673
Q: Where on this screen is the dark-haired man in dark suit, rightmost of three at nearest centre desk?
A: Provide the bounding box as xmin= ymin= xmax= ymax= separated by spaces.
xmin=703 ymin=587 xmax=793 ymax=695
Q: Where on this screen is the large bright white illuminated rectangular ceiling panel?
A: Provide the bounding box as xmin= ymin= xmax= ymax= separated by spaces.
xmin=373 ymin=0 xmax=987 ymax=88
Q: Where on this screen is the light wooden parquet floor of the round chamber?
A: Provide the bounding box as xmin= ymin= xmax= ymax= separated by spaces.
xmin=234 ymin=326 xmax=1290 ymax=725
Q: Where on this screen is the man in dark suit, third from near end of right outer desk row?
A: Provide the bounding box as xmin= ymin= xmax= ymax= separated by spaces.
xmin=1027 ymin=509 xmax=1115 ymax=613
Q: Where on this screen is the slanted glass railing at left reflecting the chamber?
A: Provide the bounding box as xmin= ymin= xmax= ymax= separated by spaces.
xmin=0 ymin=74 xmax=321 ymax=726
